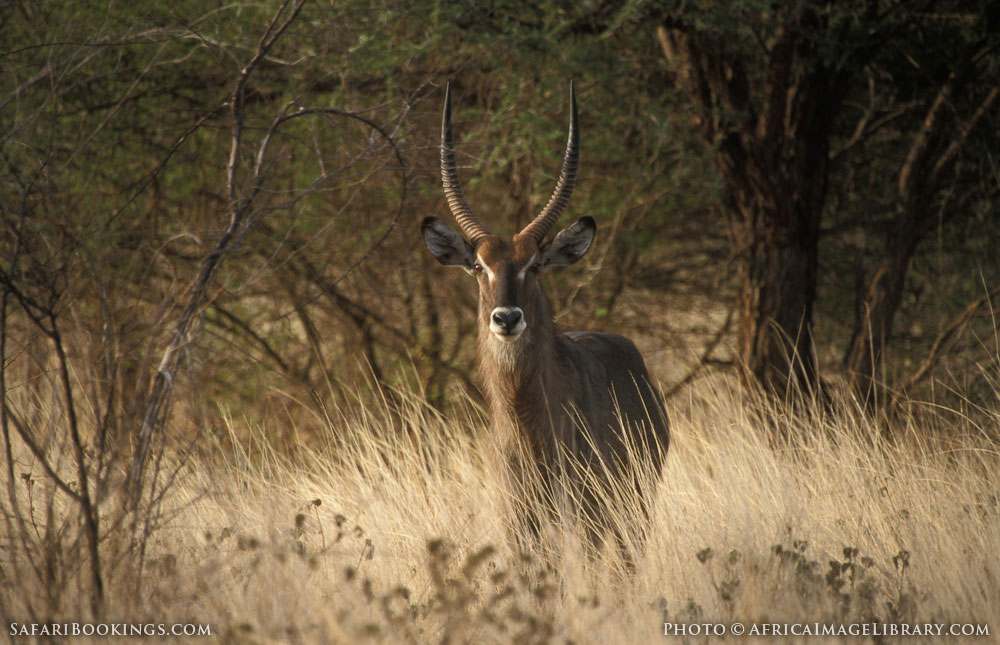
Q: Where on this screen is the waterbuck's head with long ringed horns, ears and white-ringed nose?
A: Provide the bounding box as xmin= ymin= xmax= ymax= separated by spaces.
xmin=421 ymin=83 xmax=596 ymax=344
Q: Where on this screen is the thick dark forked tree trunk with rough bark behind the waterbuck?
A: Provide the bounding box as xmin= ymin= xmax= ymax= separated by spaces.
xmin=657 ymin=21 xmax=844 ymax=399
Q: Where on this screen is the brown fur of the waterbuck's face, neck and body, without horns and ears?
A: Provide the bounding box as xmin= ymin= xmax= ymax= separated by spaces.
xmin=475 ymin=235 xmax=669 ymax=560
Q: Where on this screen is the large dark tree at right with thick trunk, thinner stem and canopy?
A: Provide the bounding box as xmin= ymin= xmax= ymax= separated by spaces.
xmin=658 ymin=1 xmax=1000 ymax=403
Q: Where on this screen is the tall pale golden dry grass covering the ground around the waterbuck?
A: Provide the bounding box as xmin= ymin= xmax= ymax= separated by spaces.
xmin=0 ymin=374 xmax=1000 ymax=645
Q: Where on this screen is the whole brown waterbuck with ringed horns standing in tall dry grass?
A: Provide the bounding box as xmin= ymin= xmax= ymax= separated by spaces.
xmin=421 ymin=84 xmax=669 ymax=561
